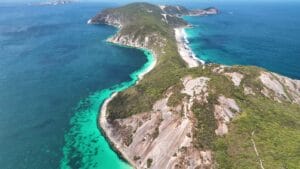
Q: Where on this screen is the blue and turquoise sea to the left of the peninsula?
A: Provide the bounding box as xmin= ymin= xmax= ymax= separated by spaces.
xmin=0 ymin=3 xmax=153 ymax=169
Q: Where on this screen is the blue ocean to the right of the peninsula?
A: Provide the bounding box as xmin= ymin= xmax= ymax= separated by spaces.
xmin=185 ymin=2 xmax=300 ymax=79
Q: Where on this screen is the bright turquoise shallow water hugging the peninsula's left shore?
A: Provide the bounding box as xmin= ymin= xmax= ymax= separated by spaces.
xmin=60 ymin=45 xmax=155 ymax=169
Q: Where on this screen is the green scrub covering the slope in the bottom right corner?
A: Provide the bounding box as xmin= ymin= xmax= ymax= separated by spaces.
xmin=215 ymin=96 xmax=300 ymax=168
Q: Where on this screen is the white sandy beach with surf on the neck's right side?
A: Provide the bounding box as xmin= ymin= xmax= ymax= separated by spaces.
xmin=174 ymin=27 xmax=205 ymax=68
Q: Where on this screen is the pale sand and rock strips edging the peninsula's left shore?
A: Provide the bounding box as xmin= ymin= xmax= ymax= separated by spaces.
xmin=98 ymin=39 xmax=157 ymax=167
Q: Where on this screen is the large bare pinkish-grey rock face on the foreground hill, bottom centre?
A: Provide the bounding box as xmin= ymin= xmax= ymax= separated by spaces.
xmin=102 ymin=77 xmax=213 ymax=169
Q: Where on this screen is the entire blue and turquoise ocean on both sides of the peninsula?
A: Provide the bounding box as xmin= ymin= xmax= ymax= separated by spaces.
xmin=0 ymin=3 xmax=300 ymax=169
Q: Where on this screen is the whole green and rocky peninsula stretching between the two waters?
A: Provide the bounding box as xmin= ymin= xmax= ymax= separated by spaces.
xmin=88 ymin=3 xmax=300 ymax=169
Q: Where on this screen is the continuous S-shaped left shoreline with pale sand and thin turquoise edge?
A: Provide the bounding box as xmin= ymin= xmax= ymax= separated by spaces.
xmin=98 ymin=38 xmax=157 ymax=166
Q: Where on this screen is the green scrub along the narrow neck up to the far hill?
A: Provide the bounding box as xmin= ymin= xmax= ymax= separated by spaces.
xmin=108 ymin=3 xmax=185 ymax=120
